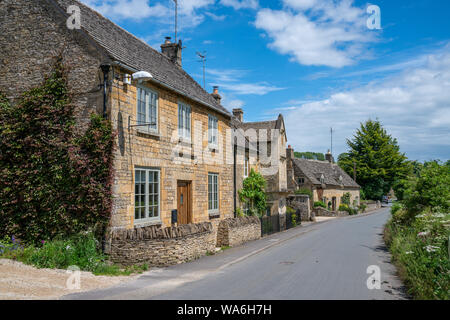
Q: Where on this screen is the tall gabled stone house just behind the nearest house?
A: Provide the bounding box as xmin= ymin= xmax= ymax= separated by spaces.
xmin=233 ymin=108 xmax=289 ymax=215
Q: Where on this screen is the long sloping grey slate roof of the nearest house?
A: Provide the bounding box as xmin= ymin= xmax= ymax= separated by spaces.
xmin=49 ymin=0 xmax=231 ymax=117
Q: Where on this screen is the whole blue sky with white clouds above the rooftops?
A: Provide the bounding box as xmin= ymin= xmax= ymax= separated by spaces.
xmin=82 ymin=0 xmax=450 ymax=160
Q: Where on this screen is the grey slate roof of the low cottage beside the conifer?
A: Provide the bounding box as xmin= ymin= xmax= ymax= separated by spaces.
xmin=294 ymin=158 xmax=360 ymax=188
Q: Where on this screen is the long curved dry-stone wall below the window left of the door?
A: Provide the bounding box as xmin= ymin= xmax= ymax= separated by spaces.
xmin=106 ymin=222 xmax=216 ymax=267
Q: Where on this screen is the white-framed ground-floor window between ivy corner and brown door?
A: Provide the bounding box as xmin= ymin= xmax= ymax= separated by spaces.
xmin=134 ymin=167 xmax=161 ymax=224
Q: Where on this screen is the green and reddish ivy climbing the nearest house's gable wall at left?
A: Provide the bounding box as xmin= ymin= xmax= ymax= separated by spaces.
xmin=0 ymin=60 xmax=114 ymax=242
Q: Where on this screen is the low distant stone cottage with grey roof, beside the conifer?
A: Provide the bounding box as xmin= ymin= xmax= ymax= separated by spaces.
xmin=287 ymin=146 xmax=360 ymax=211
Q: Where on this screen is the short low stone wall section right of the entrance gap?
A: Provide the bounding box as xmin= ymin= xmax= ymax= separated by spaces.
xmin=217 ymin=216 xmax=261 ymax=247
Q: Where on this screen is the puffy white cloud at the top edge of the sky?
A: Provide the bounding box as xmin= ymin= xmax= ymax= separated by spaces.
xmin=255 ymin=0 xmax=376 ymax=67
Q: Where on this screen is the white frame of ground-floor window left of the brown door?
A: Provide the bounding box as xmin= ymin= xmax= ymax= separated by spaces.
xmin=133 ymin=167 xmax=161 ymax=225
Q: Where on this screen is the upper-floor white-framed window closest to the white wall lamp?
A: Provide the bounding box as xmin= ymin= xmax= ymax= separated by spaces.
xmin=136 ymin=85 xmax=159 ymax=133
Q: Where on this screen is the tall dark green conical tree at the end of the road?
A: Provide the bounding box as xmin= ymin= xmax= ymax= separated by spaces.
xmin=338 ymin=119 xmax=412 ymax=200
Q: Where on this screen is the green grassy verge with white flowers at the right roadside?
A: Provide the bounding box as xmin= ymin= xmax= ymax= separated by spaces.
xmin=384 ymin=205 xmax=450 ymax=300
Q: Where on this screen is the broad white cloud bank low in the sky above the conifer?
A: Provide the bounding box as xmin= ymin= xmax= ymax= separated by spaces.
xmin=285 ymin=46 xmax=450 ymax=160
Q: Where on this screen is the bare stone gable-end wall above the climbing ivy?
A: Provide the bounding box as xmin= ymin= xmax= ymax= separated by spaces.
xmin=0 ymin=0 xmax=109 ymax=131
